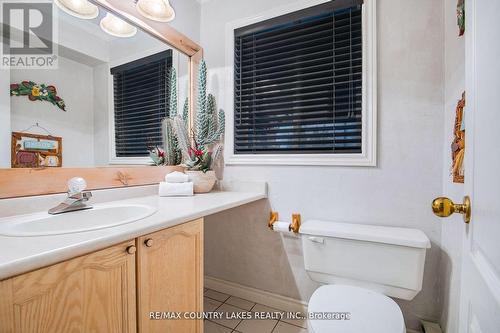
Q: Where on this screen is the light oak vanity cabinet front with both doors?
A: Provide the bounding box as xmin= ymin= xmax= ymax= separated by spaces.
xmin=0 ymin=219 xmax=203 ymax=333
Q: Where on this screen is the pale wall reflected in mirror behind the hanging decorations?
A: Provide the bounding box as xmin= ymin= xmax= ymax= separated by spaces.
xmin=10 ymin=57 xmax=94 ymax=167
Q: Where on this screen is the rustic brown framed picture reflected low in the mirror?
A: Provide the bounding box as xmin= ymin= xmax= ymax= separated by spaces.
xmin=11 ymin=132 xmax=62 ymax=168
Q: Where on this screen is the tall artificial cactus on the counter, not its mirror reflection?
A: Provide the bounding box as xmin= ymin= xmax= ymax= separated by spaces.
xmin=169 ymin=60 xmax=225 ymax=172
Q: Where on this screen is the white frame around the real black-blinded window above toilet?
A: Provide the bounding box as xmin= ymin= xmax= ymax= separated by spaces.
xmin=224 ymin=0 xmax=377 ymax=166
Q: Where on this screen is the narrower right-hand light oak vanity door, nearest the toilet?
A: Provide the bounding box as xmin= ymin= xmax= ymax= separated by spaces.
xmin=137 ymin=219 xmax=203 ymax=333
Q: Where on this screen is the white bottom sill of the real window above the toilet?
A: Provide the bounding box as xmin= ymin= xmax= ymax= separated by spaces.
xmin=225 ymin=154 xmax=377 ymax=167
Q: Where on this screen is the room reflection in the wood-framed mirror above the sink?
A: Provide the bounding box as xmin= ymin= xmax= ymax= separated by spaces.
xmin=0 ymin=3 xmax=189 ymax=168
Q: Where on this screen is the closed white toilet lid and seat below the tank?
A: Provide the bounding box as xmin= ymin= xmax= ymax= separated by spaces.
xmin=308 ymin=285 xmax=406 ymax=333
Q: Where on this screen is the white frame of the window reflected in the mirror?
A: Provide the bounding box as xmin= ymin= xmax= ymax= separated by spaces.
xmin=108 ymin=45 xmax=180 ymax=165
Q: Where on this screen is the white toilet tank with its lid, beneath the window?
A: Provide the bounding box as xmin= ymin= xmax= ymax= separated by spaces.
xmin=300 ymin=220 xmax=431 ymax=300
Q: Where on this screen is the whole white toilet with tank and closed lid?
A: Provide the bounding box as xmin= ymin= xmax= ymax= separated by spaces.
xmin=300 ymin=220 xmax=431 ymax=333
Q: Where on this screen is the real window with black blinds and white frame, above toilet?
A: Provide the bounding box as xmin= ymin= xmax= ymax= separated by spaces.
xmin=229 ymin=0 xmax=375 ymax=165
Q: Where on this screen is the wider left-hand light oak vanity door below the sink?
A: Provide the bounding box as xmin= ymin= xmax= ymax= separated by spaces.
xmin=0 ymin=241 xmax=137 ymax=333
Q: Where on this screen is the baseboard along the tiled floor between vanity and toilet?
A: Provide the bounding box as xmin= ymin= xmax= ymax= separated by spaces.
xmin=205 ymin=276 xmax=307 ymax=312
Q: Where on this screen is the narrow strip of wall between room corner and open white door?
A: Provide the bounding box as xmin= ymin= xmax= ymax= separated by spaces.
xmin=441 ymin=0 xmax=465 ymax=333
